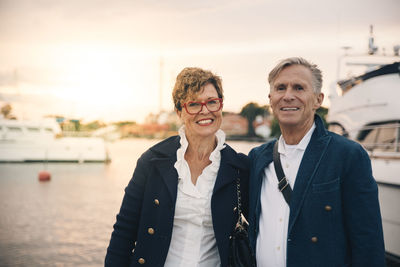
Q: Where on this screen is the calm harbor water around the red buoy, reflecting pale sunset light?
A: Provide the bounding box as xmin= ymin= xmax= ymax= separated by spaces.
xmin=0 ymin=139 xmax=259 ymax=266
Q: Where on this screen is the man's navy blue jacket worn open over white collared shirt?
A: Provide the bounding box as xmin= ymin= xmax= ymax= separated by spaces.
xmin=249 ymin=116 xmax=385 ymax=267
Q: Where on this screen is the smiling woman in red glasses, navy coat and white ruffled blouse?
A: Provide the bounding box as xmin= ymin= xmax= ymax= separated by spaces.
xmin=105 ymin=68 xmax=248 ymax=267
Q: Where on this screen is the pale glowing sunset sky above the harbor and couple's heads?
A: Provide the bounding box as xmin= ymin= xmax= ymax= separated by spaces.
xmin=0 ymin=0 xmax=400 ymax=122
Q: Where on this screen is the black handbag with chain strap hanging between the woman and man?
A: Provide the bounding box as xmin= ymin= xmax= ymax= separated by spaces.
xmin=228 ymin=178 xmax=256 ymax=267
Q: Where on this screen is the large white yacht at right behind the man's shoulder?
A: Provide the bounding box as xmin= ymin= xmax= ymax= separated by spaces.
xmin=327 ymin=26 xmax=400 ymax=266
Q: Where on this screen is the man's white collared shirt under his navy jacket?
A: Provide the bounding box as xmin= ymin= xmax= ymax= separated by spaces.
xmin=256 ymin=123 xmax=315 ymax=267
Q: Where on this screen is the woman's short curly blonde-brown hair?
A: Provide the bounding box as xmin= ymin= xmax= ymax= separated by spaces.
xmin=172 ymin=68 xmax=224 ymax=111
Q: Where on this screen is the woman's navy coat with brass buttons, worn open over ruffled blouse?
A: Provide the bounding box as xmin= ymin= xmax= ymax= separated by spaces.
xmin=105 ymin=136 xmax=249 ymax=267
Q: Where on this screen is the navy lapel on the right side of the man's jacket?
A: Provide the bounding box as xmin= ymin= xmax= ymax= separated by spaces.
xmin=288 ymin=134 xmax=330 ymax=233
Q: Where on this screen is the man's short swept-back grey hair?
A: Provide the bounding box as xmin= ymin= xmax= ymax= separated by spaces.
xmin=268 ymin=57 xmax=322 ymax=94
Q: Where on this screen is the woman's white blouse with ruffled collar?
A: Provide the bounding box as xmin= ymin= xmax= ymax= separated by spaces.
xmin=164 ymin=126 xmax=225 ymax=267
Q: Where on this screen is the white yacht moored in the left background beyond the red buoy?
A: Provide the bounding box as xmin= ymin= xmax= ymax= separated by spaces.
xmin=0 ymin=119 xmax=110 ymax=163
